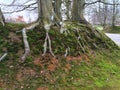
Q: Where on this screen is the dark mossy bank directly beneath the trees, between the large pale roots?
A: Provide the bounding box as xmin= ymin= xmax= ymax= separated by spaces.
xmin=0 ymin=22 xmax=119 ymax=58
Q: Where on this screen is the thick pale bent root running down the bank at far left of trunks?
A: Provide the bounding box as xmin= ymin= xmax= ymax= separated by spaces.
xmin=21 ymin=28 xmax=30 ymax=61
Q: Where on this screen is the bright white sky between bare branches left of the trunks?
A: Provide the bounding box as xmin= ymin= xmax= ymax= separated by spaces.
xmin=0 ymin=0 xmax=37 ymax=23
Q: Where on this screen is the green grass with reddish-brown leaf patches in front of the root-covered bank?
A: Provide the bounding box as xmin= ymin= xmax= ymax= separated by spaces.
xmin=0 ymin=51 xmax=120 ymax=90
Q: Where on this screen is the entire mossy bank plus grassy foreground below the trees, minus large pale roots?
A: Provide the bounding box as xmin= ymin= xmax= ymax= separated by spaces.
xmin=0 ymin=23 xmax=120 ymax=90
